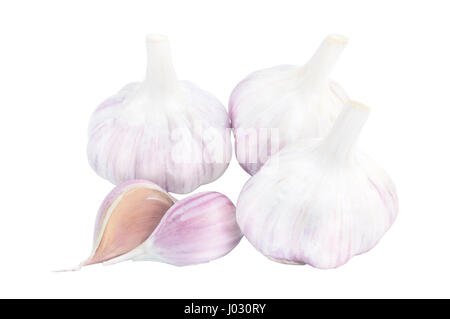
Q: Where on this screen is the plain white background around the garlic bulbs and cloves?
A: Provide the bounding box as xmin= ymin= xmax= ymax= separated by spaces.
xmin=0 ymin=0 xmax=450 ymax=298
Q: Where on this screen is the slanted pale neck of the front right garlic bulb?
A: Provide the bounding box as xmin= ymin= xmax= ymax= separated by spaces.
xmin=319 ymin=101 xmax=370 ymax=163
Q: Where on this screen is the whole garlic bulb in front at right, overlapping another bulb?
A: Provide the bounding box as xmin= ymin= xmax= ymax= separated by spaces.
xmin=236 ymin=102 xmax=398 ymax=268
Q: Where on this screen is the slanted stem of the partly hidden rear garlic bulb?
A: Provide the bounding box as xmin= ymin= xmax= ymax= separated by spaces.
xmin=306 ymin=34 xmax=348 ymax=80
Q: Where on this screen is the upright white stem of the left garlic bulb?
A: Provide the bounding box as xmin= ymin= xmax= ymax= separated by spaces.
xmin=144 ymin=34 xmax=180 ymax=98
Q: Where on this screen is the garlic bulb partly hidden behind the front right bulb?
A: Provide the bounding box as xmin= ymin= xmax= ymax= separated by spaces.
xmin=228 ymin=35 xmax=348 ymax=175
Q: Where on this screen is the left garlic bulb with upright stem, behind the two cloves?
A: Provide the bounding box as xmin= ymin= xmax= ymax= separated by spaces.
xmin=88 ymin=35 xmax=231 ymax=193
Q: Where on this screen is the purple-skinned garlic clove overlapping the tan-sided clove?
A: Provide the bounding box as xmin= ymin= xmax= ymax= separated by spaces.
xmin=127 ymin=192 xmax=242 ymax=266
